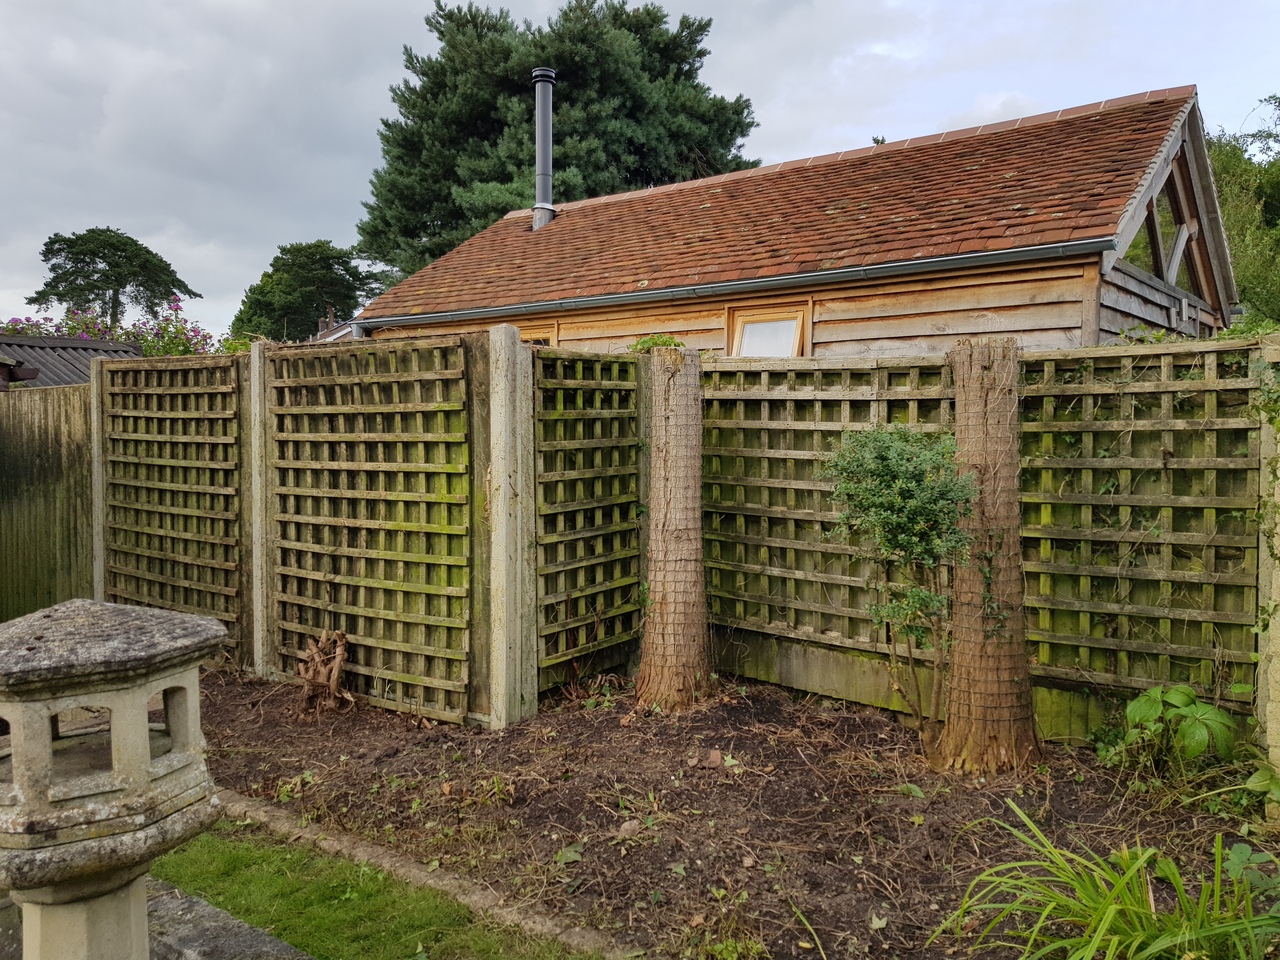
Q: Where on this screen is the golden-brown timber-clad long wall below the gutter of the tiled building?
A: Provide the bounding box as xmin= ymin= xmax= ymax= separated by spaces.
xmin=372 ymin=257 xmax=1098 ymax=357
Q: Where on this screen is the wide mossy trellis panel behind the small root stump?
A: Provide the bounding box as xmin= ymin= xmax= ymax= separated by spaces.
xmin=266 ymin=338 xmax=471 ymax=722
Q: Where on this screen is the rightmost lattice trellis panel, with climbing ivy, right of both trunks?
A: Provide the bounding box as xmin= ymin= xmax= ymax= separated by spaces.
xmin=1021 ymin=343 xmax=1261 ymax=705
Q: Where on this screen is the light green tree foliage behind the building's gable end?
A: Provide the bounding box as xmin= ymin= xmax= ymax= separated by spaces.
xmin=1208 ymin=95 xmax=1280 ymax=333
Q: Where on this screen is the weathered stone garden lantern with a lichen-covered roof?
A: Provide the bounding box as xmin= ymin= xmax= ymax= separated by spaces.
xmin=0 ymin=600 xmax=227 ymax=960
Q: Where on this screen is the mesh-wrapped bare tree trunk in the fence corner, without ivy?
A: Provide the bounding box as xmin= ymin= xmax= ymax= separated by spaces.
xmin=636 ymin=347 xmax=712 ymax=710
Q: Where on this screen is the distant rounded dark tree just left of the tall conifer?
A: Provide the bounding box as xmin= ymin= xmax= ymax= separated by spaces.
xmin=232 ymin=239 xmax=381 ymax=340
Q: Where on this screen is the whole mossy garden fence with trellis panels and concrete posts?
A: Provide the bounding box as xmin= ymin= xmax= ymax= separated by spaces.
xmin=10 ymin=328 xmax=1280 ymax=736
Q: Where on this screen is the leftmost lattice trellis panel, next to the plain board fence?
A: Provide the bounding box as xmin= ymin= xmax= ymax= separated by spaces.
xmin=102 ymin=357 xmax=246 ymax=646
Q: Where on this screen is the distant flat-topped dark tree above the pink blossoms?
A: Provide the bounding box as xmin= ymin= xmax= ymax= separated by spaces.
xmin=27 ymin=227 xmax=200 ymax=333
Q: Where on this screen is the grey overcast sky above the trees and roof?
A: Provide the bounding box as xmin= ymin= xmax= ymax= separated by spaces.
xmin=0 ymin=0 xmax=1280 ymax=333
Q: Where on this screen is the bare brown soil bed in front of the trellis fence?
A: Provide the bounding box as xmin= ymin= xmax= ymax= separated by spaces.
xmin=202 ymin=672 xmax=1258 ymax=960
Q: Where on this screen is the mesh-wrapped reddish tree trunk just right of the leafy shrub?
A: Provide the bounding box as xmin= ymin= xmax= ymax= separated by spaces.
xmin=937 ymin=339 xmax=1039 ymax=773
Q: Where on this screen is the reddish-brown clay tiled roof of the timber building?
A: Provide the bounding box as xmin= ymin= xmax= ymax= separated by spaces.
xmin=360 ymin=87 xmax=1196 ymax=320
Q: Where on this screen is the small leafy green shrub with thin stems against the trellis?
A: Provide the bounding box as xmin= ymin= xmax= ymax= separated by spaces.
xmin=822 ymin=425 xmax=978 ymax=730
